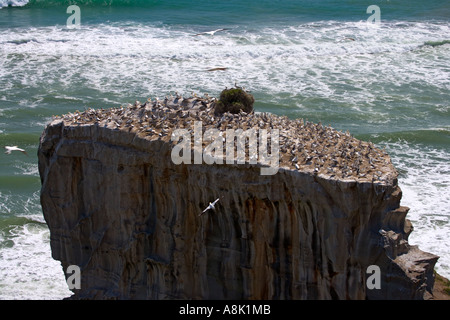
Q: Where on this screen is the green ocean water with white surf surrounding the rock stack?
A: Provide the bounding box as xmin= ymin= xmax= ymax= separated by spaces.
xmin=0 ymin=0 xmax=450 ymax=299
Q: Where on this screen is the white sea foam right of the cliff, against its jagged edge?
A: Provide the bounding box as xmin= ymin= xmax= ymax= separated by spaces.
xmin=386 ymin=141 xmax=450 ymax=278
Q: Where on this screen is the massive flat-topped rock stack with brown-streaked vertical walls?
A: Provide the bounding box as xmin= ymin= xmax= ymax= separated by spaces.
xmin=38 ymin=99 xmax=438 ymax=299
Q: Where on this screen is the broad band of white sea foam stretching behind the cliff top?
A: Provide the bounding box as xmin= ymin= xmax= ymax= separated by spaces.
xmin=0 ymin=22 xmax=450 ymax=103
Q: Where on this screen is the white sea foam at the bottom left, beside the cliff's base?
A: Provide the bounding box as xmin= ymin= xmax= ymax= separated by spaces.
xmin=0 ymin=191 xmax=71 ymax=300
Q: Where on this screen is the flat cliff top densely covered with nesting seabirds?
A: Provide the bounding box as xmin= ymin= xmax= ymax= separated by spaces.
xmin=55 ymin=95 xmax=397 ymax=183
